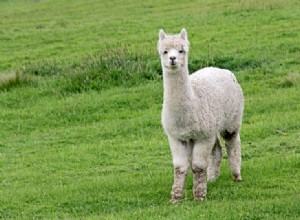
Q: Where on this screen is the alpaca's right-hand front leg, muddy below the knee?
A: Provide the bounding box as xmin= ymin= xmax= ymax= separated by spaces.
xmin=192 ymin=139 xmax=215 ymax=201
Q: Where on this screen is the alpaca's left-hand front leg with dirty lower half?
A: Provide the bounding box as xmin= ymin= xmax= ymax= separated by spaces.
xmin=169 ymin=137 xmax=190 ymax=203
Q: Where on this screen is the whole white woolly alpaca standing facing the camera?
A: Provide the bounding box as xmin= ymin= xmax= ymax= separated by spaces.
xmin=158 ymin=29 xmax=244 ymax=203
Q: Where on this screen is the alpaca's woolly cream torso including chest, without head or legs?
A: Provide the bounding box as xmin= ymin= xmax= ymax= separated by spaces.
xmin=162 ymin=67 xmax=243 ymax=141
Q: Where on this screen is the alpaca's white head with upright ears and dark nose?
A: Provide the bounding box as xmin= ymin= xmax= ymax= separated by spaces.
xmin=158 ymin=29 xmax=189 ymax=70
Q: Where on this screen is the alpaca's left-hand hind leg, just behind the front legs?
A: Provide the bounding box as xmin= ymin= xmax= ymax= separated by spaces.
xmin=207 ymin=137 xmax=222 ymax=181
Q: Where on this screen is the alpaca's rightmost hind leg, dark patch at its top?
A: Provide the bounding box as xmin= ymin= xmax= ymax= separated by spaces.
xmin=224 ymin=133 xmax=242 ymax=181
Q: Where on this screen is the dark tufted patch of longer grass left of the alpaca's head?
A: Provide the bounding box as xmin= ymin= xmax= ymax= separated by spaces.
xmin=22 ymin=45 xmax=161 ymax=93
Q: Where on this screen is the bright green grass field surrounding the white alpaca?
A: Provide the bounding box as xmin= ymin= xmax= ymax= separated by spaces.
xmin=0 ymin=0 xmax=300 ymax=219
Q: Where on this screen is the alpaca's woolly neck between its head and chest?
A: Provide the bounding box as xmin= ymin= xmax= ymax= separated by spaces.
xmin=163 ymin=67 xmax=193 ymax=107
